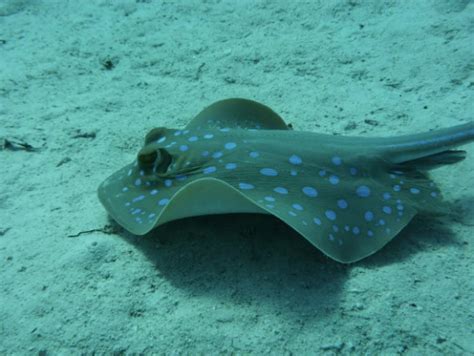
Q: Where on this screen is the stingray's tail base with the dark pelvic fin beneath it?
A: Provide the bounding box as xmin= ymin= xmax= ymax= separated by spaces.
xmin=379 ymin=122 xmax=474 ymax=170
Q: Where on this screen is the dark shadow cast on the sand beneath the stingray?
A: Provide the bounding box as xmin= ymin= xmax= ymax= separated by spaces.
xmin=110 ymin=206 xmax=456 ymax=317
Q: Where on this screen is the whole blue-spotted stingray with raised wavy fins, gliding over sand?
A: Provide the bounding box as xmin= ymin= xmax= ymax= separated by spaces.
xmin=98 ymin=99 xmax=474 ymax=263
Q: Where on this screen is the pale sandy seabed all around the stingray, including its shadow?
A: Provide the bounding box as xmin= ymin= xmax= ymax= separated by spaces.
xmin=0 ymin=0 xmax=474 ymax=355
